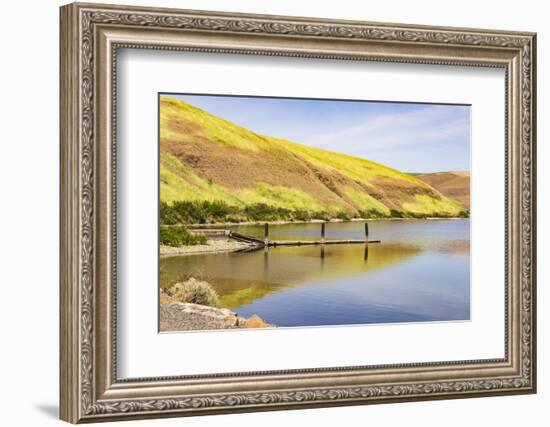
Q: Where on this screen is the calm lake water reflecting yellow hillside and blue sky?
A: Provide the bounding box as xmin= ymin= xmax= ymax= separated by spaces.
xmin=160 ymin=219 xmax=470 ymax=327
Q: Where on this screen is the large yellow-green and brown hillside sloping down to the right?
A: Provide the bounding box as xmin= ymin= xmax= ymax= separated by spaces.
xmin=160 ymin=97 xmax=463 ymax=221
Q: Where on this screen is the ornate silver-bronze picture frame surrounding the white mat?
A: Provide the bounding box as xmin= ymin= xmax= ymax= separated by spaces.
xmin=60 ymin=3 xmax=536 ymax=423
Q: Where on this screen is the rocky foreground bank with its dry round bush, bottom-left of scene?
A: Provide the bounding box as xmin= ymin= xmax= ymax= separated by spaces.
xmin=160 ymin=277 xmax=274 ymax=332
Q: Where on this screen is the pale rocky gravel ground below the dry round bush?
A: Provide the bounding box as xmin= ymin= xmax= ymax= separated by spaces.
xmin=160 ymin=302 xmax=273 ymax=332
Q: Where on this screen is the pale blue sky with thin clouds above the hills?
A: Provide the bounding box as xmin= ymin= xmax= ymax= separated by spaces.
xmin=168 ymin=94 xmax=470 ymax=172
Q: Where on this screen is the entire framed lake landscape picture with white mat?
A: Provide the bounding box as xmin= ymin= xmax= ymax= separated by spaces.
xmin=60 ymin=4 xmax=536 ymax=423
